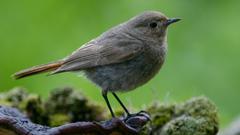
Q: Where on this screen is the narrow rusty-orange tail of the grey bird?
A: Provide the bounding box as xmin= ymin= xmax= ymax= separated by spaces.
xmin=13 ymin=61 xmax=62 ymax=79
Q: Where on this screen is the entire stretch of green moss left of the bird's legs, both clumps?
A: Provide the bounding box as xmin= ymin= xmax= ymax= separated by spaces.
xmin=0 ymin=88 xmax=106 ymax=126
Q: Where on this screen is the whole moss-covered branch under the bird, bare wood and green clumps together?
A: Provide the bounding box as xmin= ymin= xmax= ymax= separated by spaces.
xmin=0 ymin=88 xmax=218 ymax=135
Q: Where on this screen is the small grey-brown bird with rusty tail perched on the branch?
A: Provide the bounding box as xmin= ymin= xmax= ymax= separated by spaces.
xmin=13 ymin=11 xmax=181 ymax=117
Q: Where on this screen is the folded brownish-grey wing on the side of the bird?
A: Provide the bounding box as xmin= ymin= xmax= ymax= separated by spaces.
xmin=53 ymin=36 xmax=143 ymax=73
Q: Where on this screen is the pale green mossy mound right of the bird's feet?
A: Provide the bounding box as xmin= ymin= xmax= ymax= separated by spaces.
xmin=143 ymin=97 xmax=219 ymax=135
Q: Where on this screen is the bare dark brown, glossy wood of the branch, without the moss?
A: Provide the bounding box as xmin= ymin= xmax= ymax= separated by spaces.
xmin=0 ymin=106 xmax=149 ymax=135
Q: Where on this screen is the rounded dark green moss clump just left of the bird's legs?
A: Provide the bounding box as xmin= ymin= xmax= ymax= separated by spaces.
xmin=45 ymin=88 xmax=104 ymax=122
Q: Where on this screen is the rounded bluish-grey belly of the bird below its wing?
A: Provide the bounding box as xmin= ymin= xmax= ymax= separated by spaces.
xmin=85 ymin=56 xmax=163 ymax=91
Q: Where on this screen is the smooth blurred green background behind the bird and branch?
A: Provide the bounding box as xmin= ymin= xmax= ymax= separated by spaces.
xmin=0 ymin=0 xmax=240 ymax=126
